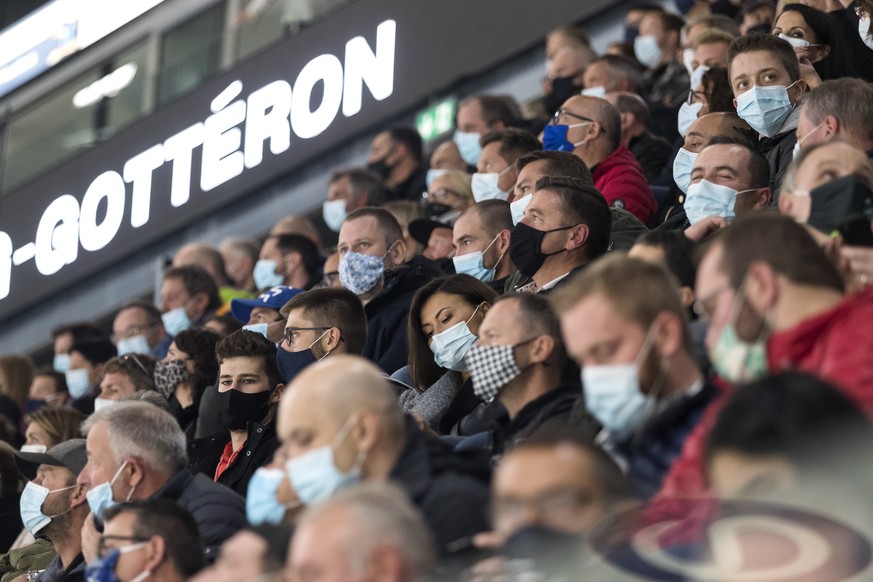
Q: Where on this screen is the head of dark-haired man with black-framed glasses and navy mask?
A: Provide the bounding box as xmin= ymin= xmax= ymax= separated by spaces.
xmin=276 ymin=288 xmax=367 ymax=384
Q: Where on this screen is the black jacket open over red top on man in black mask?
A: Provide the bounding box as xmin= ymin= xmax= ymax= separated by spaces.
xmin=188 ymin=422 xmax=279 ymax=497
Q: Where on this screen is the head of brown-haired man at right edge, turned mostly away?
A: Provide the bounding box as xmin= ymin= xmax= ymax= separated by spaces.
xmin=795 ymin=79 xmax=873 ymax=157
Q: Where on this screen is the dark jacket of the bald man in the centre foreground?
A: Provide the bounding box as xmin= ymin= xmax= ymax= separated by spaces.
xmin=390 ymin=418 xmax=489 ymax=556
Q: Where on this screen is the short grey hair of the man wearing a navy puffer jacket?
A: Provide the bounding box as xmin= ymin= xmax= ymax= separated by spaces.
xmin=82 ymin=402 xmax=188 ymax=475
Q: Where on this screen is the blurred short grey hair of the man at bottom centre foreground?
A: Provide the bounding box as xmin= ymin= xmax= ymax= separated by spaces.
xmin=297 ymin=482 xmax=436 ymax=580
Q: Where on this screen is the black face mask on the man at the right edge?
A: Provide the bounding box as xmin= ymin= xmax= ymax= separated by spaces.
xmin=807 ymin=174 xmax=873 ymax=246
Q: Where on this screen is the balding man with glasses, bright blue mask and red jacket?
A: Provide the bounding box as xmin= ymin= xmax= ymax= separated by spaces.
xmin=543 ymin=95 xmax=657 ymax=222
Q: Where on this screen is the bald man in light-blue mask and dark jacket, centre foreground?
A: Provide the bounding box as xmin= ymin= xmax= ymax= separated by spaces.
xmin=277 ymin=355 xmax=488 ymax=555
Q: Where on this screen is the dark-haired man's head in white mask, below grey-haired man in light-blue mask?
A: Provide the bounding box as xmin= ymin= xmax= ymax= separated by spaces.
xmin=471 ymin=127 xmax=542 ymax=202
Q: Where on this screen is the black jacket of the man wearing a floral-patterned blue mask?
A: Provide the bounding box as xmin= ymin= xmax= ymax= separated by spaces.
xmin=362 ymin=256 xmax=443 ymax=374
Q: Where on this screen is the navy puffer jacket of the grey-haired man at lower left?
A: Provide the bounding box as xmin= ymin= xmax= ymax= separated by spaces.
xmin=152 ymin=470 xmax=246 ymax=564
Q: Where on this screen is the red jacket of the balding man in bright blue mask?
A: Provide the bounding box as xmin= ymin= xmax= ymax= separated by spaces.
xmin=591 ymin=145 xmax=658 ymax=223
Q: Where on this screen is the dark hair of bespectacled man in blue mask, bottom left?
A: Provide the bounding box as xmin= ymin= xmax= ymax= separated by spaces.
xmin=103 ymin=499 xmax=204 ymax=578
